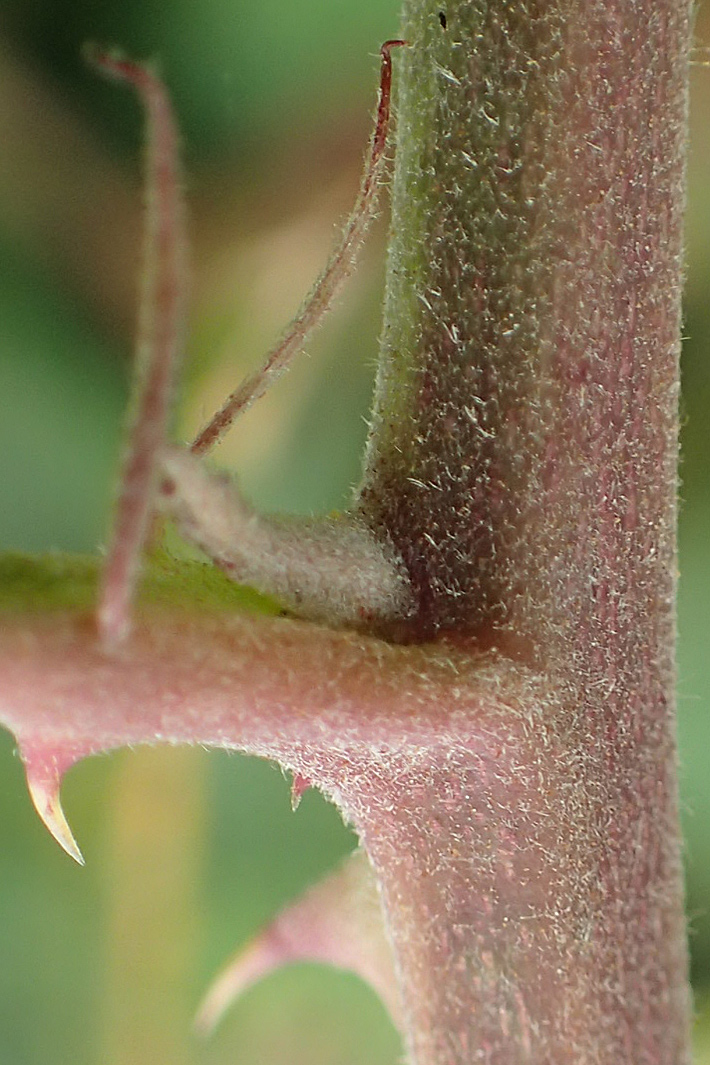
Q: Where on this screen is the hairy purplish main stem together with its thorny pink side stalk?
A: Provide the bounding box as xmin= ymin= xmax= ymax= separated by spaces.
xmin=0 ymin=0 xmax=690 ymax=1065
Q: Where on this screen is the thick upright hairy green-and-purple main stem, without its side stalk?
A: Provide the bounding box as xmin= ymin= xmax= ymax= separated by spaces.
xmin=341 ymin=0 xmax=690 ymax=1065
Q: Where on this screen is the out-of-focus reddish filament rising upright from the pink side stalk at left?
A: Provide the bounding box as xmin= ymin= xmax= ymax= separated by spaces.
xmin=90 ymin=51 xmax=186 ymax=648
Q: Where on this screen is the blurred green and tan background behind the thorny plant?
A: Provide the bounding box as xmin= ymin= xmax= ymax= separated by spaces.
xmin=0 ymin=0 xmax=710 ymax=1065
